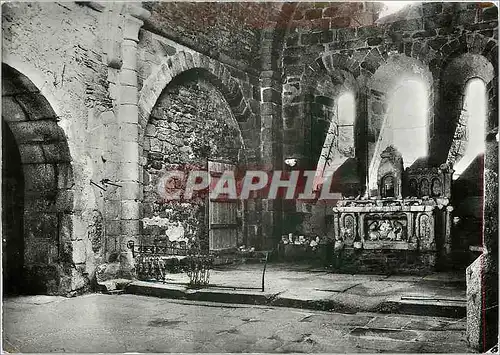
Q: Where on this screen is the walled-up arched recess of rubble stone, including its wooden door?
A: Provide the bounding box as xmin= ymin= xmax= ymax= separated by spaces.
xmin=141 ymin=69 xmax=244 ymax=253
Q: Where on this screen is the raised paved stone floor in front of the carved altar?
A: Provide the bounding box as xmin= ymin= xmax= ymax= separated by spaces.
xmin=124 ymin=264 xmax=466 ymax=316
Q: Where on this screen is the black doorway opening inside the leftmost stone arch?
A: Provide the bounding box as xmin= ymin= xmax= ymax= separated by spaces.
xmin=2 ymin=120 xmax=24 ymax=295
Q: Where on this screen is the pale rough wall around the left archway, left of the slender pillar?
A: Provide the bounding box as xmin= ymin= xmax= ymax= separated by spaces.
xmin=2 ymin=3 xmax=112 ymax=293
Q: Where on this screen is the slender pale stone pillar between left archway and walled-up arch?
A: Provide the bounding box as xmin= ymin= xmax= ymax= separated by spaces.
xmin=118 ymin=4 xmax=150 ymax=275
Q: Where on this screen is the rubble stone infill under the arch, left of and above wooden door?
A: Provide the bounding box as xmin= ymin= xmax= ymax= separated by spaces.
xmin=141 ymin=72 xmax=244 ymax=247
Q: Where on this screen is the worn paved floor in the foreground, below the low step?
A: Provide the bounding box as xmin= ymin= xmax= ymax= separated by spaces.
xmin=3 ymin=294 xmax=472 ymax=353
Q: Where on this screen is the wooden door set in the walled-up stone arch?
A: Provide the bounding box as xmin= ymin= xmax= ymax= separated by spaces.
xmin=208 ymin=161 xmax=238 ymax=250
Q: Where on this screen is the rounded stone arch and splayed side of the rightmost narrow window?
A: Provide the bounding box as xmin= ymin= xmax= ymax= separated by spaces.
xmin=440 ymin=53 xmax=498 ymax=166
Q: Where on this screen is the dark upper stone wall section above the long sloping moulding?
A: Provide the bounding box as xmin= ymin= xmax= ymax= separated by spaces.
xmin=145 ymin=2 xmax=280 ymax=75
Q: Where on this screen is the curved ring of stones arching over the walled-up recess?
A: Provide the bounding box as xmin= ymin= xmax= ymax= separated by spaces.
xmin=138 ymin=51 xmax=255 ymax=143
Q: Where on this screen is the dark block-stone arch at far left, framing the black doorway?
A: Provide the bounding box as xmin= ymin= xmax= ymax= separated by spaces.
xmin=2 ymin=63 xmax=76 ymax=293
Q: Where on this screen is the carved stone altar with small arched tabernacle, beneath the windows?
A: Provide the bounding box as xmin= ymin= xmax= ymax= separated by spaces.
xmin=333 ymin=146 xmax=452 ymax=273
